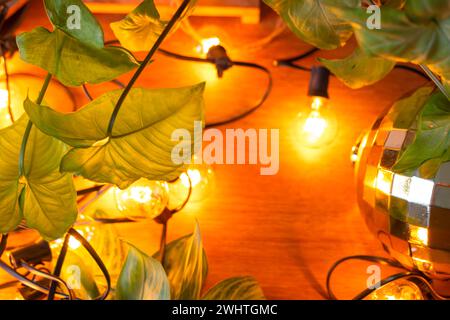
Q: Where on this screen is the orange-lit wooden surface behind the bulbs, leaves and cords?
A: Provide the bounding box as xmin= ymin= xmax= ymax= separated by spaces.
xmin=0 ymin=1 xmax=430 ymax=299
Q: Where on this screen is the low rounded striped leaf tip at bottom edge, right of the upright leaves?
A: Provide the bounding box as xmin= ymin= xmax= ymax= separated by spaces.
xmin=203 ymin=277 xmax=266 ymax=300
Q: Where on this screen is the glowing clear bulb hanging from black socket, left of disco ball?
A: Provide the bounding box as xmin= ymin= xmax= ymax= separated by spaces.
xmin=298 ymin=97 xmax=337 ymax=148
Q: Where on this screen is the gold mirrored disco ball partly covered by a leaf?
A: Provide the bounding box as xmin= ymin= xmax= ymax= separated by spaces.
xmin=352 ymin=89 xmax=450 ymax=279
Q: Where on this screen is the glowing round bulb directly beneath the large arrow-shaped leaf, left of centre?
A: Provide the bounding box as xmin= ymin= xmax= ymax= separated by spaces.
xmin=114 ymin=179 xmax=169 ymax=220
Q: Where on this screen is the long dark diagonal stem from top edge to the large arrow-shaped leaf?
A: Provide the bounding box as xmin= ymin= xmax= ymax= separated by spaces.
xmin=107 ymin=0 xmax=191 ymax=138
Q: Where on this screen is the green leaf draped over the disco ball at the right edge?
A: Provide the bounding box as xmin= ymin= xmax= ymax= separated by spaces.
xmin=393 ymin=92 xmax=450 ymax=173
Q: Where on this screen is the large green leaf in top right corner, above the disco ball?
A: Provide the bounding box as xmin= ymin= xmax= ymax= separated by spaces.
xmin=330 ymin=5 xmax=450 ymax=97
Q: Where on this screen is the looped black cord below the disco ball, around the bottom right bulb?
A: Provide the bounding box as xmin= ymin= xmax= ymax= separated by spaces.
xmin=326 ymin=255 xmax=450 ymax=300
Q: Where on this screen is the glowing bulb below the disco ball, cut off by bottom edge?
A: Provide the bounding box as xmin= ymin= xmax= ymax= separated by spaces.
xmin=365 ymin=279 xmax=424 ymax=300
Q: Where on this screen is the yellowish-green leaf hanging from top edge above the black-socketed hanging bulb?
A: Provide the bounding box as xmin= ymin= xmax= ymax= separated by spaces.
xmin=264 ymin=0 xmax=360 ymax=50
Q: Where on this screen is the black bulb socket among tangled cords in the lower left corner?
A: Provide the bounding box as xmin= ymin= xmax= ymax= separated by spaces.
xmin=9 ymin=240 xmax=52 ymax=268
